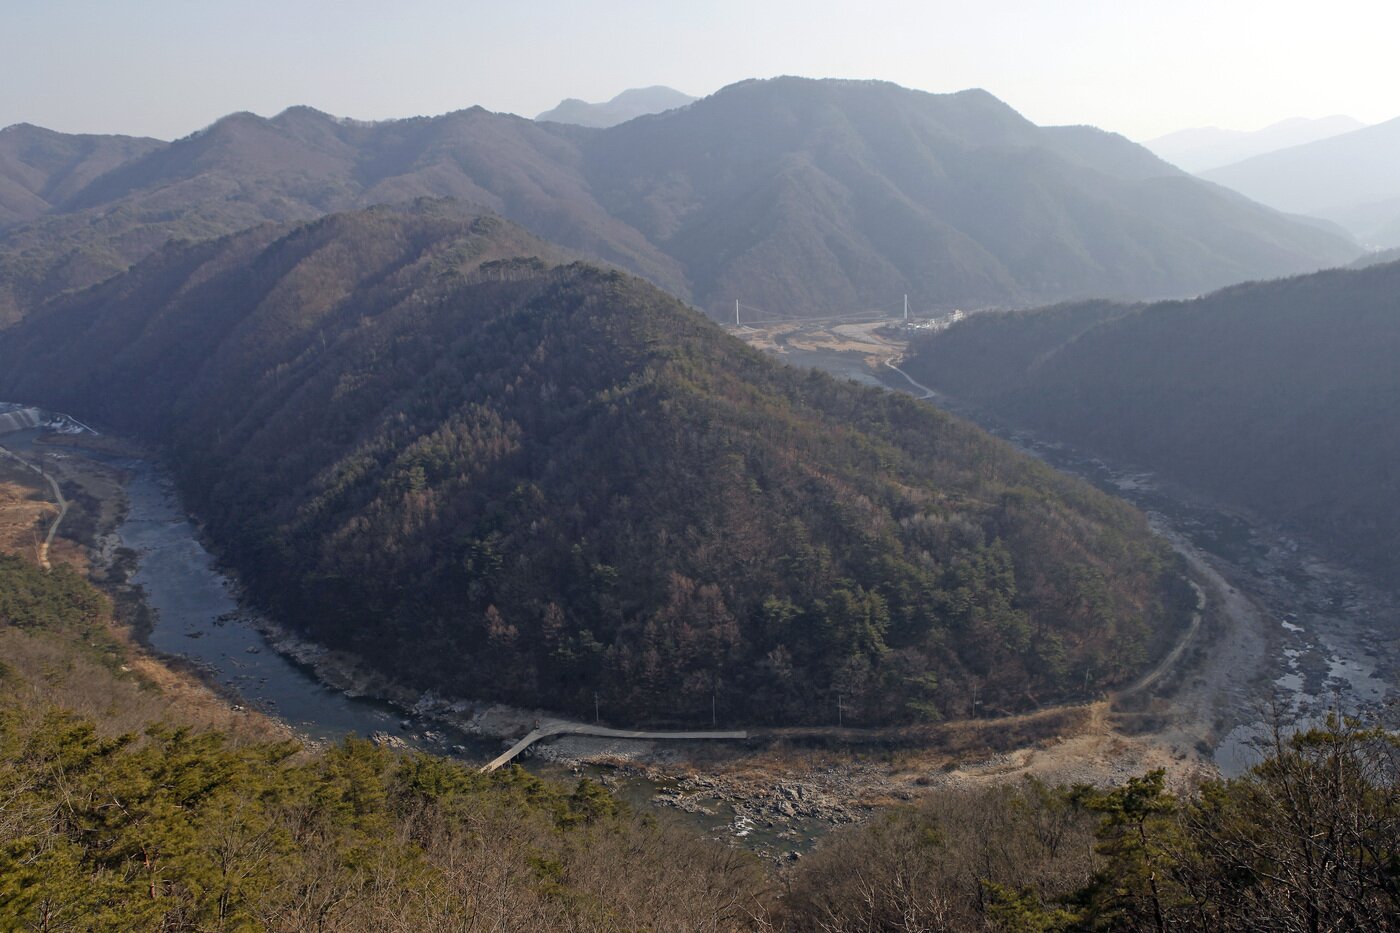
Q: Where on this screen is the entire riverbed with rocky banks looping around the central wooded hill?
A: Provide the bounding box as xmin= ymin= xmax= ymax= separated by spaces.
xmin=6 ymin=299 xmax=1396 ymax=859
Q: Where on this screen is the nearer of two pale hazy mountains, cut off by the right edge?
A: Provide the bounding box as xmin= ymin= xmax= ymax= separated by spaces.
xmin=1203 ymin=118 xmax=1400 ymax=247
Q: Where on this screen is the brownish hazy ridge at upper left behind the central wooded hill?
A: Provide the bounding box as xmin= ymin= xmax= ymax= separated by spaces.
xmin=0 ymin=108 xmax=686 ymax=324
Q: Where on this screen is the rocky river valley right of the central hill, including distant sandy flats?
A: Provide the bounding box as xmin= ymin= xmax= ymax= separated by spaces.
xmin=738 ymin=319 xmax=1400 ymax=775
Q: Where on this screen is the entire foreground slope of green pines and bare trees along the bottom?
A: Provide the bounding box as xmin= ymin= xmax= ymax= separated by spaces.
xmin=0 ymin=515 xmax=1400 ymax=933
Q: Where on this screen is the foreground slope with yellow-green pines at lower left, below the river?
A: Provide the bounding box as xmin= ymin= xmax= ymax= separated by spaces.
xmin=0 ymin=552 xmax=763 ymax=932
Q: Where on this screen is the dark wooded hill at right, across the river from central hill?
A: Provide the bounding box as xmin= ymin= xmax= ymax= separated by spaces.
xmin=907 ymin=262 xmax=1400 ymax=583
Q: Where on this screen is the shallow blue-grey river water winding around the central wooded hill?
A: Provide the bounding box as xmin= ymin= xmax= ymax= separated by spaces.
xmin=13 ymin=381 xmax=1400 ymax=852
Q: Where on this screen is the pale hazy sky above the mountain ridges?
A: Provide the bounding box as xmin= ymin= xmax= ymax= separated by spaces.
xmin=0 ymin=0 xmax=1400 ymax=139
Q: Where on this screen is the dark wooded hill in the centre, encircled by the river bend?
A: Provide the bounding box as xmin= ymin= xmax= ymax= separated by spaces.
xmin=0 ymin=205 xmax=1186 ymax=723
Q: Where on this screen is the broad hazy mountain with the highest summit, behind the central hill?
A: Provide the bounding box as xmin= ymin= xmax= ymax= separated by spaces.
xmin=587 ymin=78 xmax=1354 ymax=314
